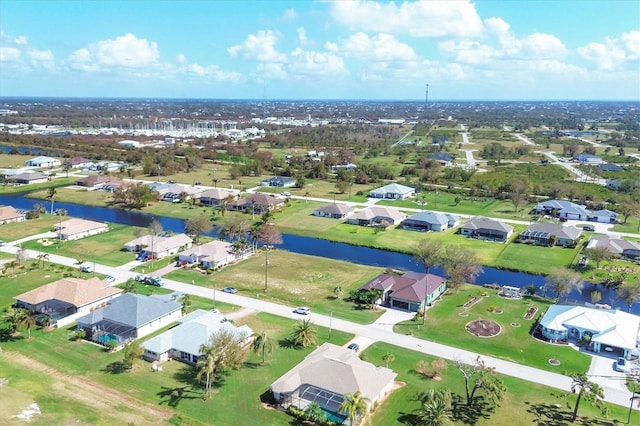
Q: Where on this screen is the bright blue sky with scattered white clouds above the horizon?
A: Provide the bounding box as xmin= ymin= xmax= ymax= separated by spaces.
xmin=0 ymin=0 xmax=640 ymax=101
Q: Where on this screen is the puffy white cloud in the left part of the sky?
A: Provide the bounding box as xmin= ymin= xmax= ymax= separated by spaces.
xmin=69 ymin=33 xmax=160 ymax=71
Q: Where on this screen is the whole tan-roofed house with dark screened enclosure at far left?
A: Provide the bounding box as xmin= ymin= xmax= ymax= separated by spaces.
xmin=14 ymin=277 xmax=122 ymax=327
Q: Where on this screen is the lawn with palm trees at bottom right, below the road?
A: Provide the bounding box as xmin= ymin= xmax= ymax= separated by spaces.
xmin=362 ymin=342 xmax=640 ymax=426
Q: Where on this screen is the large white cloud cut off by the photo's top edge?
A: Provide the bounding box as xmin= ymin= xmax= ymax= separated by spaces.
xmin=329 ymin=0 xmax=483 ymax=37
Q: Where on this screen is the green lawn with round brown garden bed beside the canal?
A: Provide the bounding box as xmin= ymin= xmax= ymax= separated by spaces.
xmin=395 ymin=286 xmax=591 ymax=374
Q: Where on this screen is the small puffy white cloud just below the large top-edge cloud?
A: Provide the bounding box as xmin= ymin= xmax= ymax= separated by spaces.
xmin=341 ymin=32 xmax=418 ymax=61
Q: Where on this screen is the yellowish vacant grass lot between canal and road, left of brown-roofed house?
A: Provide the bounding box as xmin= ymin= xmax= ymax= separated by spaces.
xmin=166 ymin=250 xmax=383 ymax=324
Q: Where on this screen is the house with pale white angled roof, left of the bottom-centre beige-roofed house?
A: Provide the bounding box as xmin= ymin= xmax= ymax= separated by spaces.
xmin=142 ymin=309 xmax=253 ymax=365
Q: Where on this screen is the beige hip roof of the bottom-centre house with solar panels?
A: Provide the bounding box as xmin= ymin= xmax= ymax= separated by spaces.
xmin=271 ymin=343 xmax=397 ymax=401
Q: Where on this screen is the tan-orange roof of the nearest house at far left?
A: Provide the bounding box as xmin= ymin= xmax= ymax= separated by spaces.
xmin=15 ymin=277 xmax=122 ymax=308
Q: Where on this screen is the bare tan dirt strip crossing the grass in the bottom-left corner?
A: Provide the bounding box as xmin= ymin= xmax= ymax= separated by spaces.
xmin=2 ymin=351 xmax=174 ymax=425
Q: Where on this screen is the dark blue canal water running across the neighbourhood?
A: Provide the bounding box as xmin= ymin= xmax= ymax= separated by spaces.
xmin=0 ymin=194 xmax=640 ymax=314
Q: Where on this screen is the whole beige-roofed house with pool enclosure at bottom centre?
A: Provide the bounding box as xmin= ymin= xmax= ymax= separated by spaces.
xmin=271 ymin=342 xmax=397 ymax=417
